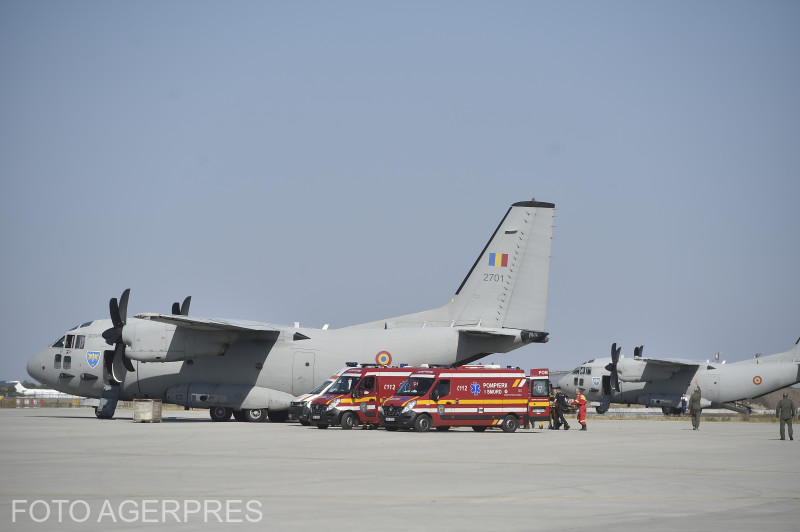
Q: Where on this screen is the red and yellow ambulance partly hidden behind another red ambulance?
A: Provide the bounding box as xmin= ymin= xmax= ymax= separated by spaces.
xmin=309 ymin=366 xmax=416 ymax=429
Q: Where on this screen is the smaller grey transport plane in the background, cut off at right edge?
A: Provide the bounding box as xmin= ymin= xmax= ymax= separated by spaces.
xmin=558 ymin=338 xmax=800 ymax=414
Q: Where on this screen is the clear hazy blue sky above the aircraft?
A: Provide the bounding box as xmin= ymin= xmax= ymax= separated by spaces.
xmin=0 ymin=0 xmax=800 ymax=379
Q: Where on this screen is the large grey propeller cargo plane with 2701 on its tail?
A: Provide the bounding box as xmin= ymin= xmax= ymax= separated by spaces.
xmin=28 ymin=200 xmax=555 ymax=422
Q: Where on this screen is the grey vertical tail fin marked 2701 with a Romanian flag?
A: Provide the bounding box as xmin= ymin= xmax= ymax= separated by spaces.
xmin=451 ymin=200 xmax=555 ymax=331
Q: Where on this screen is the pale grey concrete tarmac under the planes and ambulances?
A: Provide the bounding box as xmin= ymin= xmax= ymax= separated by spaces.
xmin=0 ymin=409 xmax=800 ymax=532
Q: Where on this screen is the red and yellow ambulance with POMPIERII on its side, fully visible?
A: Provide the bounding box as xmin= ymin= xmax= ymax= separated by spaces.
xmin=381 ymin=365 xmax=550 ymax=432
